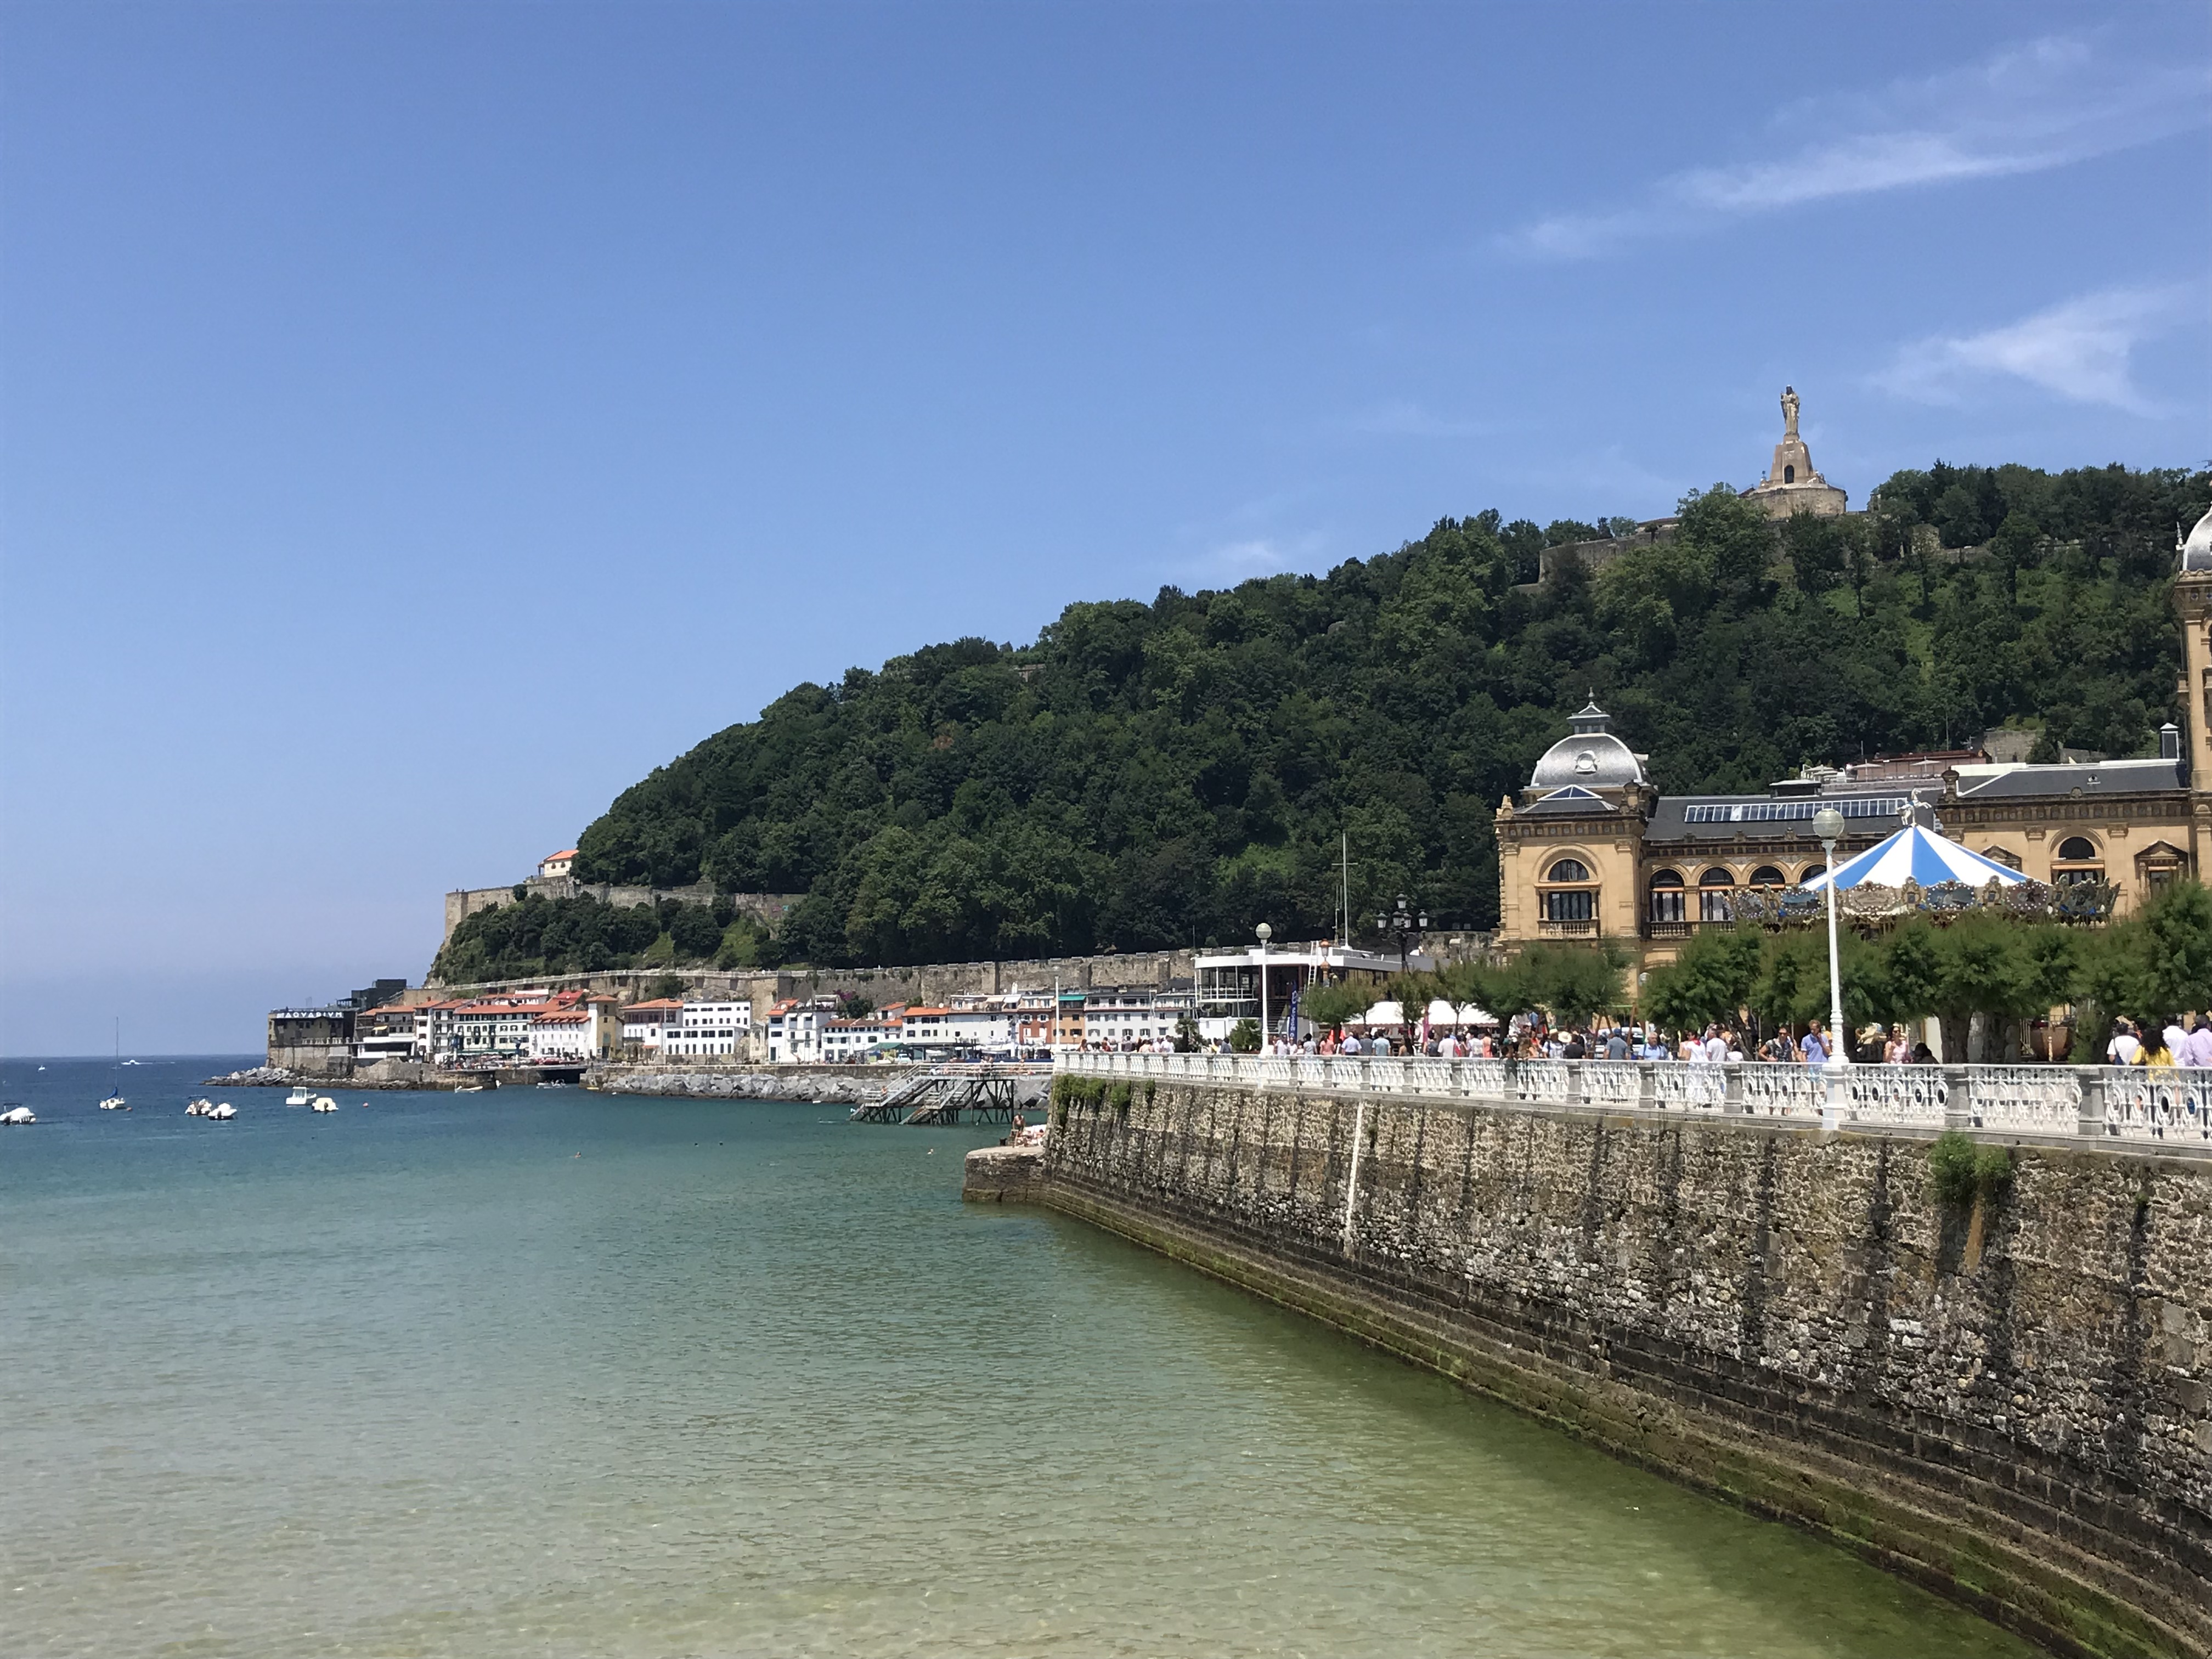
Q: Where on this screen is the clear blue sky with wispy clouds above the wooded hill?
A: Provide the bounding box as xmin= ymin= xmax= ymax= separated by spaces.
xmin=0 ymin=0 xmax=2212 ymax=1053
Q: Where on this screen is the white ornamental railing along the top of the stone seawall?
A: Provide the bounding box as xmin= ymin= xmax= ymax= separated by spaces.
xmin=1053 ymin=1053 xmax=2212 ymax=1153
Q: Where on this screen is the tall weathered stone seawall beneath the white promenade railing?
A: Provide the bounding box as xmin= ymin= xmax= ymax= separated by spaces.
xmin=1030 ymin=1082 xmax=2212 ymax=1659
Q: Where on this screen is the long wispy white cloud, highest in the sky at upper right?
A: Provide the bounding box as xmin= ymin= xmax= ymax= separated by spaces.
xmin=1502 ymin=36 xmax=2212 ymax=259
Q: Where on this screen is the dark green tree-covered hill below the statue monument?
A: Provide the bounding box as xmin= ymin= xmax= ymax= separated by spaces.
xmin=562 ymin=465 xmax=2212 ymax=967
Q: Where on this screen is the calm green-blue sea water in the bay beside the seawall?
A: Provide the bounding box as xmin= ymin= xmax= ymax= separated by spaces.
xmin=0 ymin=1062 xmax=2028 ymax=1659
